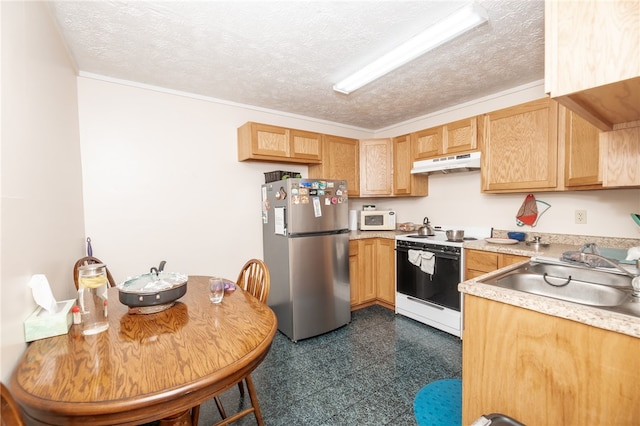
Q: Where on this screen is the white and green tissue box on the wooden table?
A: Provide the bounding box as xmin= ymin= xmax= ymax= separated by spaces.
xmin=24 ymin=299 xmax=76 ymax=342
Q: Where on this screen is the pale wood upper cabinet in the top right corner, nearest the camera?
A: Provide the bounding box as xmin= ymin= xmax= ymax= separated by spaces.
xmin=545 ymin=0 xmax=640 ymax=131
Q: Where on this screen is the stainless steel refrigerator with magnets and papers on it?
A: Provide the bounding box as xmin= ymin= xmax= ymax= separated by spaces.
xmin=262 ymin=179 xmax=351 ymax=341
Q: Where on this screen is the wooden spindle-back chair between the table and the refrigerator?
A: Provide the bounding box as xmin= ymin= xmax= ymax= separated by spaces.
xmin=191 ymin=259 xmax=271 ymax=426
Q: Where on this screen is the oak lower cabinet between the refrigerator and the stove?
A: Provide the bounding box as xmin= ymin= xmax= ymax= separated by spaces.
xmin=349 ymin=238 xmax=396 ymax=310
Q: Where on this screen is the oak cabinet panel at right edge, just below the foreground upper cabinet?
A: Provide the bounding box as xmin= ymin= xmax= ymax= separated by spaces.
xmin=602 ymin=127 xmax=640 ymax=187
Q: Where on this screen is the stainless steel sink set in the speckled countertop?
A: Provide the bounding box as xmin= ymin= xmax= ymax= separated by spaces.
xmin=479 ymin=262 xmax=640 ymax=316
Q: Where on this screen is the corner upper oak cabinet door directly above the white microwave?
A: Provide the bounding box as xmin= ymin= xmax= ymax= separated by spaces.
xmin=359 ymin=139 xmax=393 ymax=197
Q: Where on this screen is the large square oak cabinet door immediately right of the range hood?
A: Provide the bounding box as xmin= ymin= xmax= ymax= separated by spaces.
xmin=481 ymin=99 xmax=558 ymax=192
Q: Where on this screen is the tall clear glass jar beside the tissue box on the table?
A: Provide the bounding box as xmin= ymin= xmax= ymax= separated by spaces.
xmin=78 ymin=263 xmax=109 ymax=335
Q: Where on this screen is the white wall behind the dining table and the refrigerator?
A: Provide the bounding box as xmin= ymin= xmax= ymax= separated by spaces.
xmin=78 ymin=77 xmax=371 ymax=281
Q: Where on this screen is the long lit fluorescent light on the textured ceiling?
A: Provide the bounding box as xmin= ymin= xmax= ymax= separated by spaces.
xmin=333 ymin=3 xmax=487 ymax=95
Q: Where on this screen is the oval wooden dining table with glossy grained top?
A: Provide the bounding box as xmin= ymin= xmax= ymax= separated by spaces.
xmin=10 ymin=276 xmax=277 ymax=426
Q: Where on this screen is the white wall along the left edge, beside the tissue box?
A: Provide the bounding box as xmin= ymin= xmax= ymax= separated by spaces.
xmin=0 ymin=2 xmax=84 ymax=383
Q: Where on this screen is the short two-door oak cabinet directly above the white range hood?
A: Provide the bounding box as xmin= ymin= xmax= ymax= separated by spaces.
xmin=411 ymin=117 xmax=478 ymax=161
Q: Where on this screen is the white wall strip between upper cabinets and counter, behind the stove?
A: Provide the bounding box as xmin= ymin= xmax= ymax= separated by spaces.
xmin=350 ymin=171 xmax=640 ymax=238
